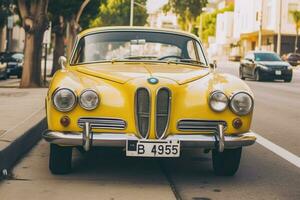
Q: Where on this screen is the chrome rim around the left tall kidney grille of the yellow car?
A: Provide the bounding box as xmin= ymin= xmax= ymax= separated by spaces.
xmin=134 ymin=87 xmax=152 ymax=139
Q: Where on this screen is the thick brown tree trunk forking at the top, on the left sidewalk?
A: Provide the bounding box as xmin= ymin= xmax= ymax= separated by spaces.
xmin=18 ymin=0 xmax=48 ymax=88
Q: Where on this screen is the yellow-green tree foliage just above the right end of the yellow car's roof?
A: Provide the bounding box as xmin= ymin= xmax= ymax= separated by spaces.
xmin=163 ymin=0 xmax=207 ymax=32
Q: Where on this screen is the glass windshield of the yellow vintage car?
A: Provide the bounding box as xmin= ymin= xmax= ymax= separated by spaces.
xmin=71 ymin=31 xmax=207 ymax=65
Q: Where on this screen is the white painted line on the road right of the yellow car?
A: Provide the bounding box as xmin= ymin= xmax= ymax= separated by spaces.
xmin=254 ymin=133 xmax=300 ymax=168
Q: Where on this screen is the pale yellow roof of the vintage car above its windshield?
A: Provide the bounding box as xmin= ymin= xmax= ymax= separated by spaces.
xmin=78 ymin=26 xmax=199 ymax=40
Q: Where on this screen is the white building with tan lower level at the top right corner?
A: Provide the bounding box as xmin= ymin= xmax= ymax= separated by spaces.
xmin=233 ymin=0 xmax=300 ymax=54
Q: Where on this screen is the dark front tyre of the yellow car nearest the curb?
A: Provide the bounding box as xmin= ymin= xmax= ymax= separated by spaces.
xmin=49 ymin=144 xmax=72 ymax=174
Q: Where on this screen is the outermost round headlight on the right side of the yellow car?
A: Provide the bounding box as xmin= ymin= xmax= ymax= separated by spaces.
xmin=230 ymin=92 xmax=253 ymax=115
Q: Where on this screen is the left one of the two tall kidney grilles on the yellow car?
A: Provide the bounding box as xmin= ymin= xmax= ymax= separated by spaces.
xmin=135 ymin=88 xmax=151 ymax=138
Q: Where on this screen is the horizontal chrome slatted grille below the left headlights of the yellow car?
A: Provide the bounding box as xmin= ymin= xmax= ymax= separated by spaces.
xmin=78 ymin=117 xmax=126 ymax=130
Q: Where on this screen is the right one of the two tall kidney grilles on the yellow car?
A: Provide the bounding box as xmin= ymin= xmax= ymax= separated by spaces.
xmin=155 ymin=88 xmax=171 ymax=139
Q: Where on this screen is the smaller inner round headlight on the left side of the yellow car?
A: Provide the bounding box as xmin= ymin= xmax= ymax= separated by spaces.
xmin=79 ymin=90 xmax=99 ymax=110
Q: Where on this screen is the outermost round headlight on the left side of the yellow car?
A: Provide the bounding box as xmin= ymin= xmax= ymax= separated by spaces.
xmin=52 ymin=88 xmax=76 ymax=112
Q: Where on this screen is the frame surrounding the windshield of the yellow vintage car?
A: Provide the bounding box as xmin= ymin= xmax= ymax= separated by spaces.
xmin=69 ymin=30 xmax=208 ymax=68
